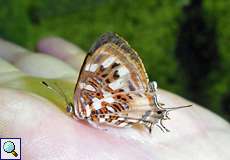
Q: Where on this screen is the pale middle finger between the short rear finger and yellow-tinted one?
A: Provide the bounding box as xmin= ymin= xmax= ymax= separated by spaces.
xmin=0 ymin=40 xmax=78 ymax=79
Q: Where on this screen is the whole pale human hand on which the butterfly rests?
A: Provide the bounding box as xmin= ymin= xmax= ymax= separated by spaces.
xmin=0 ymin=37 xmax=230 ymax=160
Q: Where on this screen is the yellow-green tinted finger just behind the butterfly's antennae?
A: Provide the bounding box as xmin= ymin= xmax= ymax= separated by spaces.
xmin=0 ymin=58 xmax=75 ymax=110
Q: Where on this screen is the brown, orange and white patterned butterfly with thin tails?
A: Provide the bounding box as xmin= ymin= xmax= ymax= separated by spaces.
xmin=43 ymin=32 xmax=191 ymax=133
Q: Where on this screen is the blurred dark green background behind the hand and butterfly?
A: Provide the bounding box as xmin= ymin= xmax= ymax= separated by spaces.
xmin=0 ymin=0 xmax=230 ymax=120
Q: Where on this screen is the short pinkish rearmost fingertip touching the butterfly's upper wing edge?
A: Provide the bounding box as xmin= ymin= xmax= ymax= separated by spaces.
xmin=37 ymin=37 xmax=85 ymax=70
